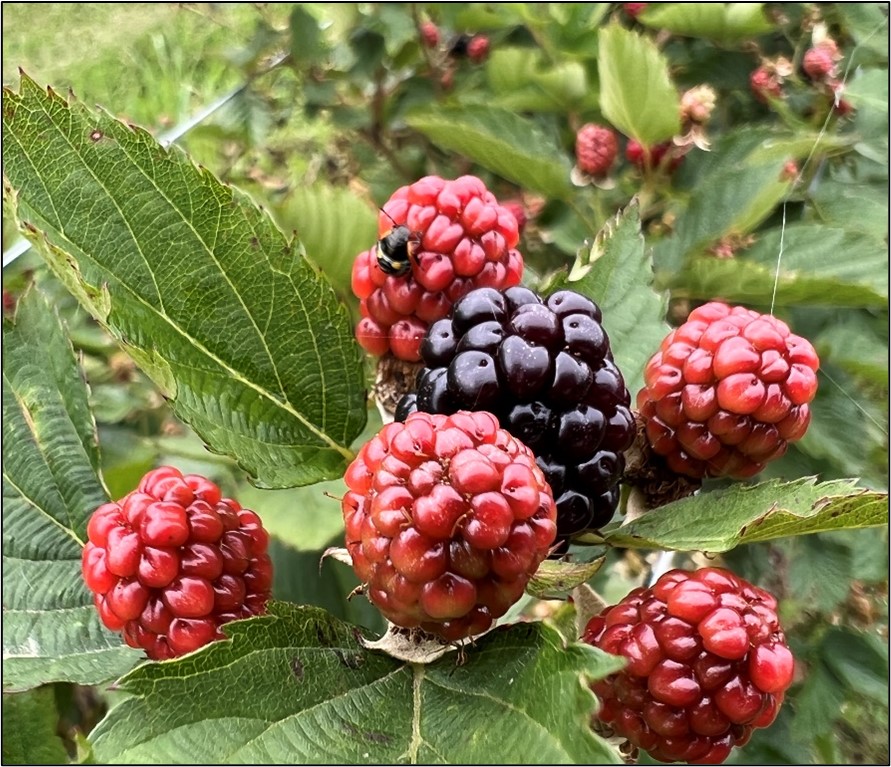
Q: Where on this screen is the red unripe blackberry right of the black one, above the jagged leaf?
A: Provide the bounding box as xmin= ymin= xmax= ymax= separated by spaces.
xmin=637 ymin=301 xmax=820 ymax=479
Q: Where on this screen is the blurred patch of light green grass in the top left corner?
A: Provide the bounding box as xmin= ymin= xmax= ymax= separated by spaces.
xmin=3 ymin=3 xmax=286 ymax=130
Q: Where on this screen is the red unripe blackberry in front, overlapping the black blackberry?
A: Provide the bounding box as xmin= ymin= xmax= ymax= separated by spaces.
xmin=342 ymin=412 xmax=556 ymax=641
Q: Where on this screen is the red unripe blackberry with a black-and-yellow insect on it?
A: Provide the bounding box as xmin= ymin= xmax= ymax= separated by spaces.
xmin=352 ymin=176 xmax=523 ymax=362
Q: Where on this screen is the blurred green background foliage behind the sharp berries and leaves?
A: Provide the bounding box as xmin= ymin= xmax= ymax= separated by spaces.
xmin=3 ymin=3 xmax=889 ymax=764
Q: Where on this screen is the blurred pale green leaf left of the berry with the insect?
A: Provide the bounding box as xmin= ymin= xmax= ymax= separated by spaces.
xmin=277 ymin=184 xmax=377 ymax=297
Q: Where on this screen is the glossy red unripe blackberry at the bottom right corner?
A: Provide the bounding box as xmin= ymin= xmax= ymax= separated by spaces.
xmin=582 ymin=567 xmax=794 ymax=764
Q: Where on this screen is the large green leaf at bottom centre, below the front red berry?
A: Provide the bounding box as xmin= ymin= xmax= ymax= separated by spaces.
xmin=91 ymin=603 xmax=621 ymax=764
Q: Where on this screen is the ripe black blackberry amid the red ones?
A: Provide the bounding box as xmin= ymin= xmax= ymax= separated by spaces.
xmin=397 ymin=286 xmax=634 ymax=541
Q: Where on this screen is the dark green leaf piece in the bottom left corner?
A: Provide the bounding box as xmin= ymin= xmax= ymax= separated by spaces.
xmin=3 ymin=687 xmax=68 ymax=764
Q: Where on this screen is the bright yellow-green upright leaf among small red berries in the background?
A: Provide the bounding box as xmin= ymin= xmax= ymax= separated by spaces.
xmin=597 ymin=23 xmax=681 ymax=146
